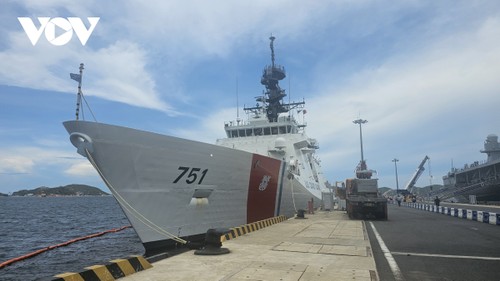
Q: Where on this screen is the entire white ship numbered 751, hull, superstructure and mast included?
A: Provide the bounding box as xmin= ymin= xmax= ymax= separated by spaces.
xmin=64 ymin=37 xmax=329 ymax=255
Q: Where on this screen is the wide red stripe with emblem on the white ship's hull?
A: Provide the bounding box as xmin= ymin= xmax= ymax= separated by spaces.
xmin=247 ymin=154 xmax=281 ymax=223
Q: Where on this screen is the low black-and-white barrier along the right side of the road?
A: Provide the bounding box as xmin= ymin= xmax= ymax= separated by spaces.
xmin=401 ymin=203 xmax=500 ymax=225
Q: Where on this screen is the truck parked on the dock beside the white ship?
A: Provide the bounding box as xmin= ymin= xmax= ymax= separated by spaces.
xmin=345 ymin=160 xmax=388 ymax=220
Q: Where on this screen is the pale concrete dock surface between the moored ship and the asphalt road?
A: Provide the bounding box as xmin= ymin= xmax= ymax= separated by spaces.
xmin=120 ymin=211 xmax=378 ymax=281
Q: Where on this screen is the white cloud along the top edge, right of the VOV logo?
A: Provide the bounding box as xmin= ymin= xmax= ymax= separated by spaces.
xmin=121 ymin=0 xmax=327 ymax=54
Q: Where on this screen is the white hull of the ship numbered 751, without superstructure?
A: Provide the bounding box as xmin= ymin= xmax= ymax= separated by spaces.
xmin=64 ymin=121 xmax=320 ymax=255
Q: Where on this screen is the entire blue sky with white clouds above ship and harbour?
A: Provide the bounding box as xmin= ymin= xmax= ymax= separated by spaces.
xmin=0 ymin=0 xmax=500 ymax=193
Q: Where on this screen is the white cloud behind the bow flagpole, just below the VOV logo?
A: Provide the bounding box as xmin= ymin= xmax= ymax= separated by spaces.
xmin=0 ymin=21 xmax=177 ymax=115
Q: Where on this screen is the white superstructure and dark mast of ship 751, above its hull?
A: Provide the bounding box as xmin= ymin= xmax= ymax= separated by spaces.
xmin=217 ymin=36 xmax=326 ymax=198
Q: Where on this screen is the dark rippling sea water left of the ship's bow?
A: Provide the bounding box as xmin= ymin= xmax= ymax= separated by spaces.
xmin=0 ymin=196 xmax=144 ymax=280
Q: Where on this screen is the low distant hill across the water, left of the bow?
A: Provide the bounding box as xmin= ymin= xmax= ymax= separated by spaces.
xmin=12 ymin=184 xmax=109 ymax=196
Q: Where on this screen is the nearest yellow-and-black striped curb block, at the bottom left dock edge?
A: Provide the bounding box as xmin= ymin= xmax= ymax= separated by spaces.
xmin=52 ymin=256 xmax=152 ymax=281
